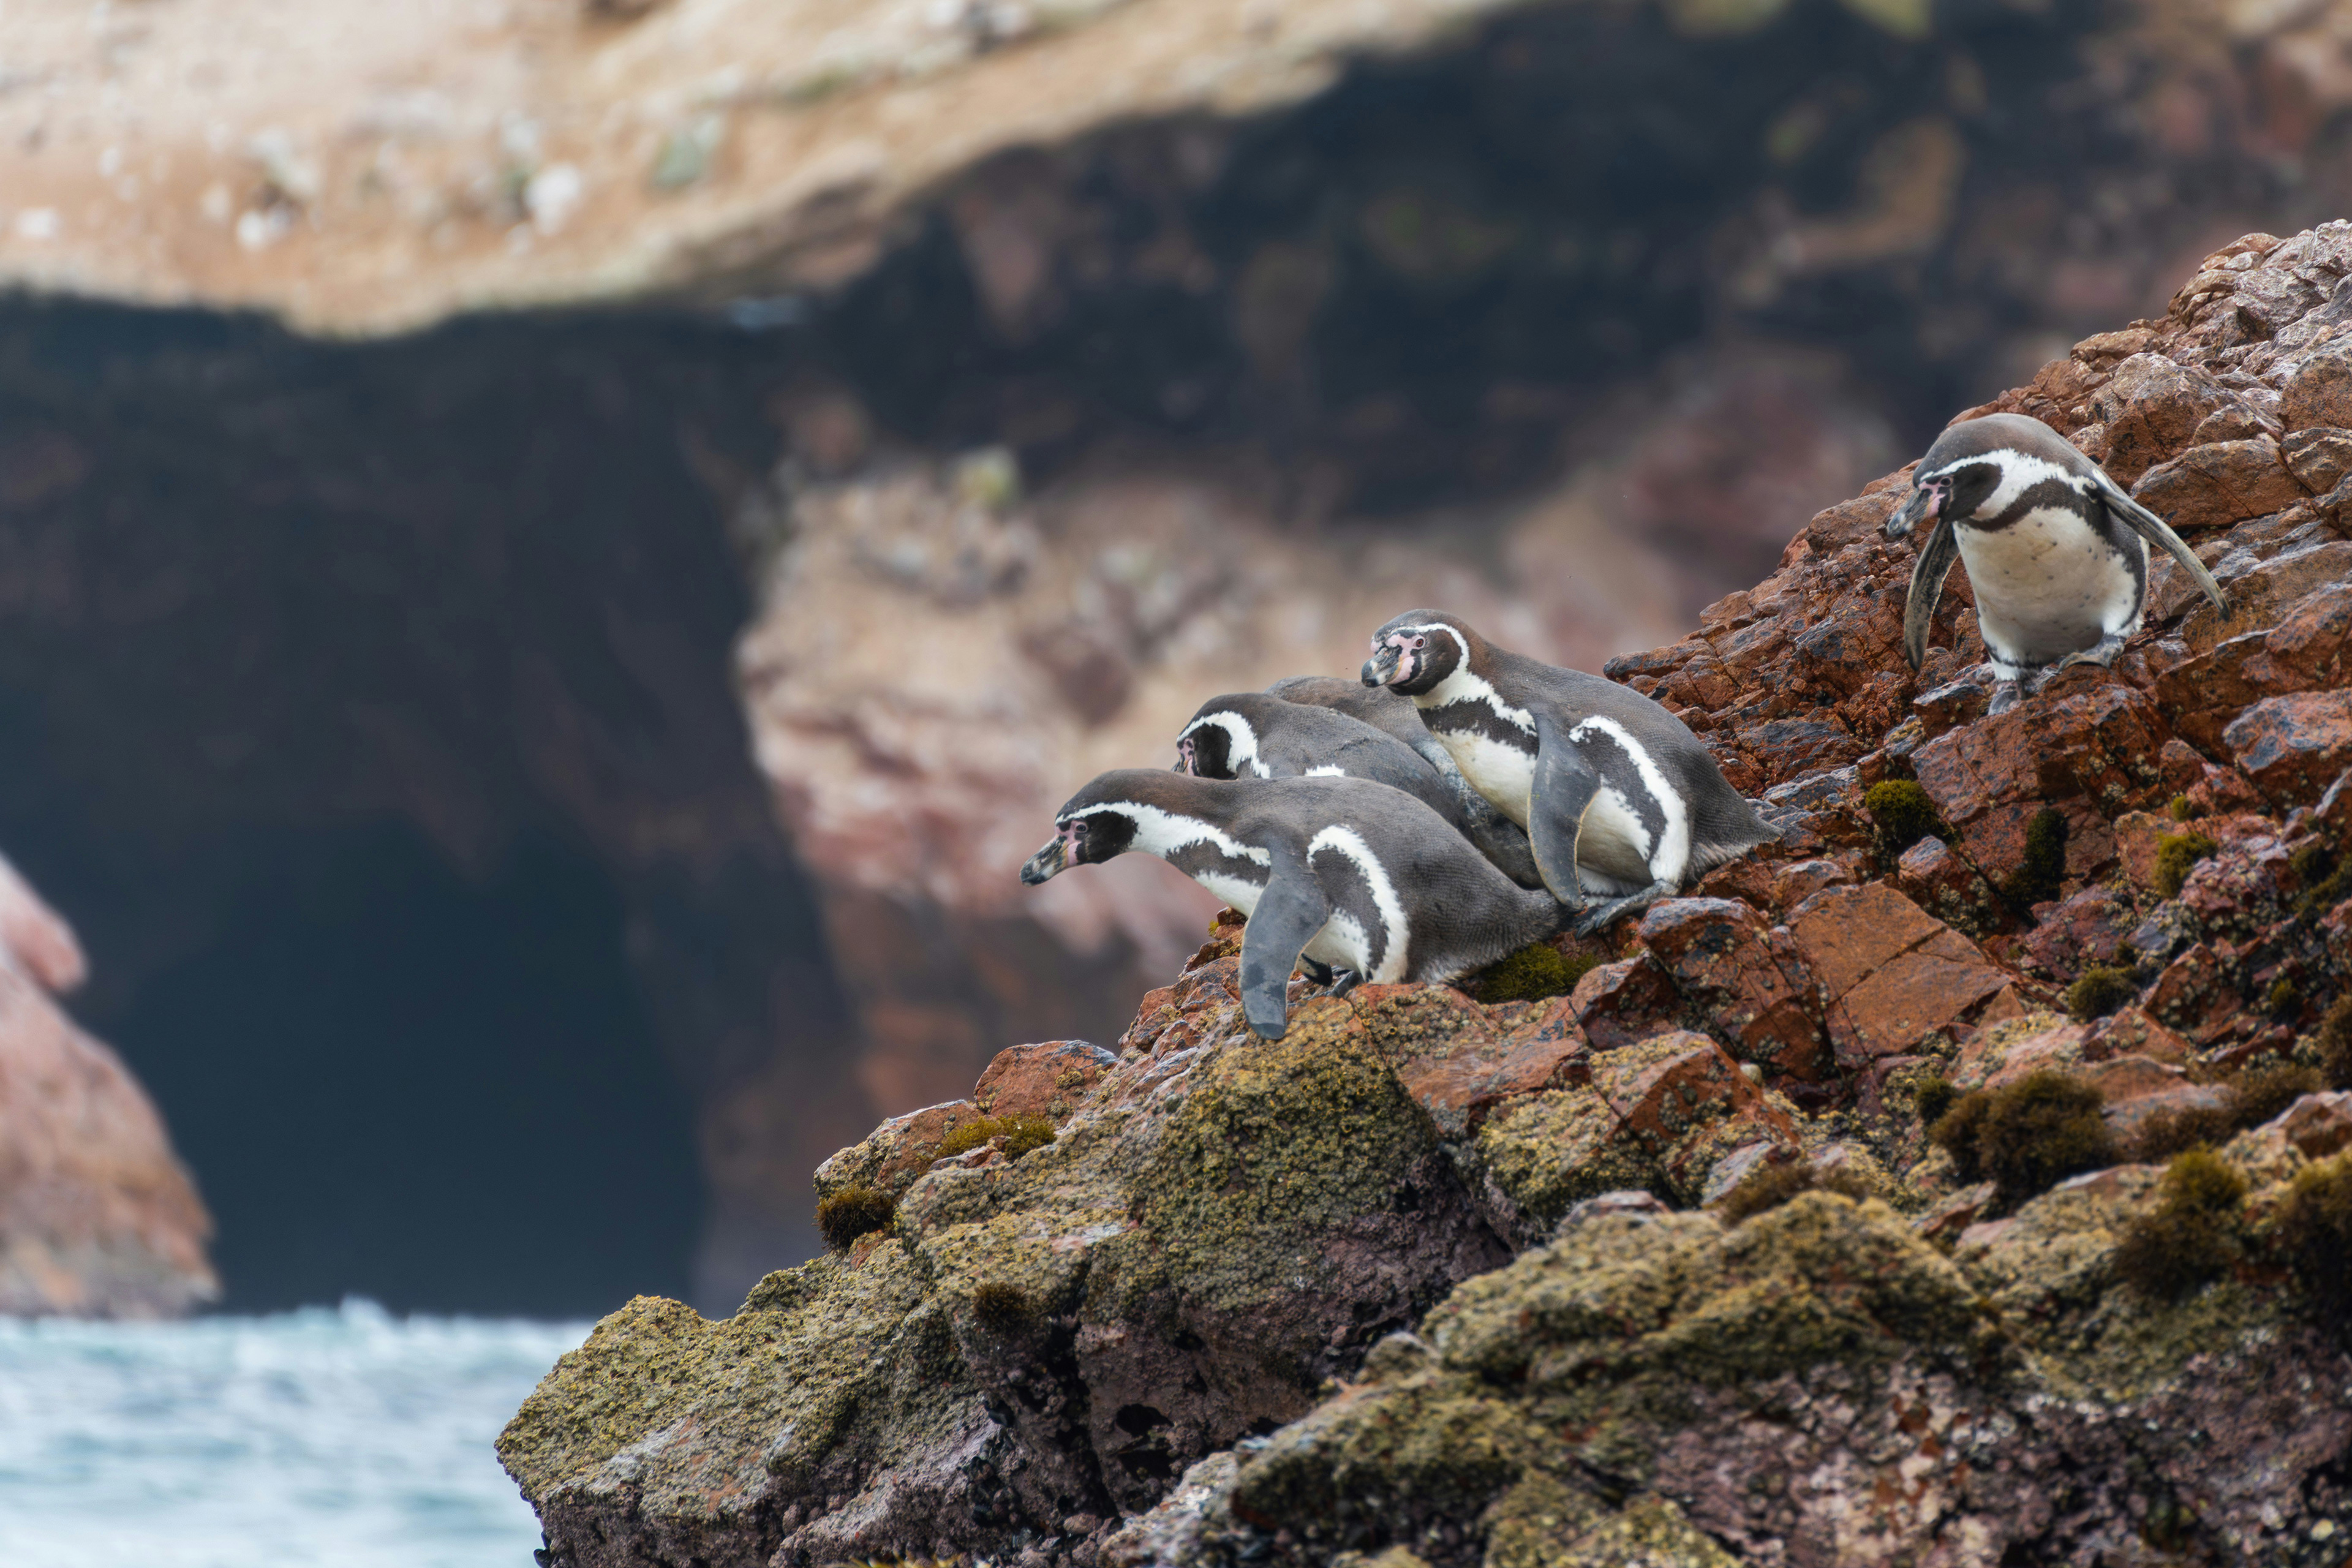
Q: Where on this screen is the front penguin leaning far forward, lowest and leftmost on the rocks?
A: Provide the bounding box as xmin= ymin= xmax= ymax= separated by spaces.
xmin=1021 ymin=769 xmax=1562 ymax=1039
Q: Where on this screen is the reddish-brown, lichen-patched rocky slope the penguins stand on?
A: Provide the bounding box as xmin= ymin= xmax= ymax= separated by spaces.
xmin=501 ymin=224 xmax=2352 ymax=1568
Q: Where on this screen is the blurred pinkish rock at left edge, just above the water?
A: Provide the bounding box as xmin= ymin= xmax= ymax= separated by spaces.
xmin=0 ymin=861 xmax=221 ymax=1316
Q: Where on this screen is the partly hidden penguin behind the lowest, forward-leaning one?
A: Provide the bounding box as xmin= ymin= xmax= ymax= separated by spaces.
xmin=1176 ymin=677 xmax=1543 ymax=886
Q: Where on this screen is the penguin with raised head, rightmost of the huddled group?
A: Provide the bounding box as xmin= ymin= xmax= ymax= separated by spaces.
xmin=1362 ymin=609 xmax=1778 ymax=936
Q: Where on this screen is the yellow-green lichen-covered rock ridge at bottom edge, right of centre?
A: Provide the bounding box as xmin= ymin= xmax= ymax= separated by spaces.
xmin=1232 ymin=1192 xmax=1988 ymax=1568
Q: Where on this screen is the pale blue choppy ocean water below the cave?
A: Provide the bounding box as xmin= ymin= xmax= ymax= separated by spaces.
xmin=0 ymin=1302 xmax=588 ymax=1568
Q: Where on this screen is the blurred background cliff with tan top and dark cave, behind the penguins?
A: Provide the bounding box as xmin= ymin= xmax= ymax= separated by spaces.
xmin=0 ymin=0 xmax=2352 ymax=1310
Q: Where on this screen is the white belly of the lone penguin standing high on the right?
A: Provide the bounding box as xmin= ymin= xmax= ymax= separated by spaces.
xmin=1959 ymin=508 xmax=2147 ymax=658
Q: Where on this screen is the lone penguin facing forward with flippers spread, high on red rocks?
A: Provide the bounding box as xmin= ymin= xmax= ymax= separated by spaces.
xmin=1879 ymin=414 xmax=2230 ymax=712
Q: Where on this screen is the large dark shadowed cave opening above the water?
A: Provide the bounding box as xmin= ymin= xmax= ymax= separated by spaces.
xmin=0 ymin=301 xmax=846 ymax=1314
